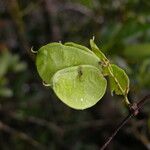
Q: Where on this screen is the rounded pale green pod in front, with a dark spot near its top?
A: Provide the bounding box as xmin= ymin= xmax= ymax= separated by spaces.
xmin=53 ymin=65 xmax=107 ymax=109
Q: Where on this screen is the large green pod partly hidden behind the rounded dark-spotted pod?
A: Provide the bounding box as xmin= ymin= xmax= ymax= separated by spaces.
xmin=36 ymin=43 xmax=101 ymax=84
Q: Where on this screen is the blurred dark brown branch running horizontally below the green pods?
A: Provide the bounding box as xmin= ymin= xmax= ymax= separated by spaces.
xmin=0 ymin=107 xmax=104 ymax=135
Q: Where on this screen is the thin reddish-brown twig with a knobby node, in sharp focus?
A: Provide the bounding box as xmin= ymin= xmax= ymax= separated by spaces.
xmin=100 ymin=94 xmax=150 ymax=150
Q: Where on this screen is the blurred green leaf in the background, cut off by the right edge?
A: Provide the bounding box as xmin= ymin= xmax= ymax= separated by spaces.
xmin=124 ymin=43 xmax=150 ymax=61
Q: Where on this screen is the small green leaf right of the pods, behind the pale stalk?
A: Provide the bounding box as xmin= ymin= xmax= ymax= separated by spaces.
xmin=109 ymin=64 xmax=129 ymax=95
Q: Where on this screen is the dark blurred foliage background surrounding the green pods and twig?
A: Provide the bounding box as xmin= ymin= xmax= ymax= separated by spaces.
xmin=0 ymin=0 xmax=150 ymax=150
